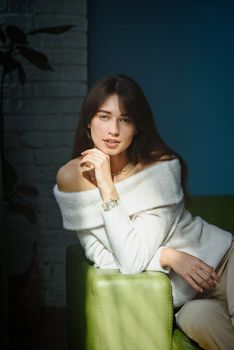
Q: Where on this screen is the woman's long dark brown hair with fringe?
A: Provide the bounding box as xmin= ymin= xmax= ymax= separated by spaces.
xmin=72 ymin=74 xmax=188 ymax=199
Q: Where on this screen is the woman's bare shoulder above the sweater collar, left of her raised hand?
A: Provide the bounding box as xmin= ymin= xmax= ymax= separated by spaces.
xmin=56 ymin=157 xmax=95 ymax=192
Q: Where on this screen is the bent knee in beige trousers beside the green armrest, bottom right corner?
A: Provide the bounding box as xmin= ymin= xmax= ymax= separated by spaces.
xmin=176 ymin=299 xmax=234 ymax=350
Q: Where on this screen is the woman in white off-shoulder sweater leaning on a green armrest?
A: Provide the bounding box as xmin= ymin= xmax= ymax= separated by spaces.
xmin=54 ymin=75 xmax=234 ymax=350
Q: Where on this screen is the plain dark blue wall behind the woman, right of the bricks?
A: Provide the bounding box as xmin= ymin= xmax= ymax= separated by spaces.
xmin=88 ymin=0 xmax=234 ymax=194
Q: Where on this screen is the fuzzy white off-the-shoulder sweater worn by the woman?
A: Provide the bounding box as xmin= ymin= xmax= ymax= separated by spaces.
xmin=54 ymin=159 xmax=232 ymax=306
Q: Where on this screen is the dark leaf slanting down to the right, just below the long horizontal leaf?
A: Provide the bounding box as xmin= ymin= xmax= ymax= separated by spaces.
xmin=17 ymin=45 xmax=54 ymax=71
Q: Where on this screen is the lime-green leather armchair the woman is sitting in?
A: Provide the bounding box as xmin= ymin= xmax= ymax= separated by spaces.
xmin=66 ymin=196 xmax=234 ymax=350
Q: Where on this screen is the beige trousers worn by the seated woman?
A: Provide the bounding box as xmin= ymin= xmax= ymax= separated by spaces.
xmin=175 ymin=241 xmax=234 ymax=350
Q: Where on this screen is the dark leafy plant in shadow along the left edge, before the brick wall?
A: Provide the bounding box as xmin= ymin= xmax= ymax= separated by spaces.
xmin=0 ymin=25 xmax=73 ymax=342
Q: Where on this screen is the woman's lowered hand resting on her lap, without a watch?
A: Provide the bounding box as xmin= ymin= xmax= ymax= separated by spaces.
xmin=160 ymin=247 xmax=220 ymax=292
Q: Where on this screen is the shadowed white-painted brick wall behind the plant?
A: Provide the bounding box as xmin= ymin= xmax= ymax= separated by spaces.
xmin=0 ymin=0 xmax=87 ymax=306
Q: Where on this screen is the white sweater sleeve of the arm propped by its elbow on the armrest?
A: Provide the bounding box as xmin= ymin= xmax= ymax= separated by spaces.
xmin=102 ymin=202 xmax=183 ymax=274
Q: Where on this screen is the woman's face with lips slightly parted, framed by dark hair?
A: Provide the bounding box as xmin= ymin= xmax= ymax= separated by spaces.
xmin=89 ymin=95 xmax=136 ymax=156
